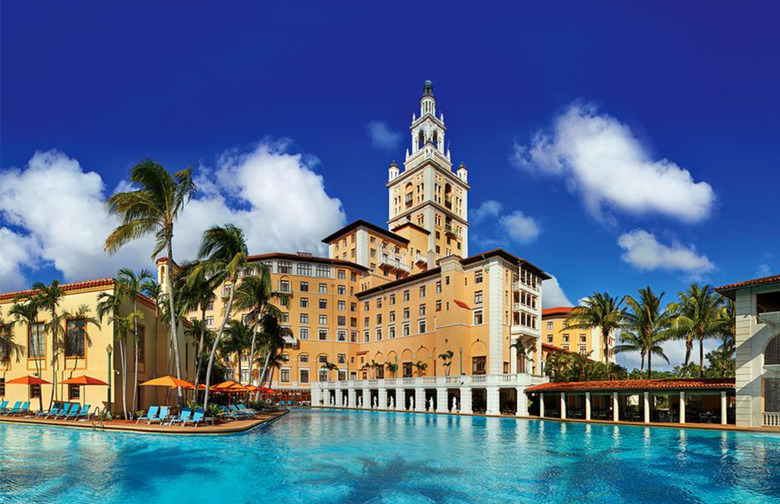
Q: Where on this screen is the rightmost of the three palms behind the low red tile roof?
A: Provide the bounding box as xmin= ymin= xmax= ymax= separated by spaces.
xmin=668 ymin=283 xmax=723 ymax=377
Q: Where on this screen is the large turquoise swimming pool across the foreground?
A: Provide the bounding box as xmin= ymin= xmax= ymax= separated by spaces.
xmin=0 ymin=410 xmax=780 ymax=504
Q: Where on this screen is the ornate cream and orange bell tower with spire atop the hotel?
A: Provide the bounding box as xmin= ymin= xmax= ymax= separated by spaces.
xmin=387 ymin=80 xmax=469 ymax=267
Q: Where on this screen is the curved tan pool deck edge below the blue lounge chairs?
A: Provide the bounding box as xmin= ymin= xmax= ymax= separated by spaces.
xmin=0 ymin=410 xmax=290 ymax=435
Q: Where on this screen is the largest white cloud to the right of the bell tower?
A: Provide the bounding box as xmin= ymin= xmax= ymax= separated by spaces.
xmin=511 ymin=104 xmax=715 ymax=222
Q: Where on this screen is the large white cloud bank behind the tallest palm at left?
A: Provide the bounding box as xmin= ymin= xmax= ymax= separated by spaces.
xmin=0 ymin=142 xmax=345 ymax=290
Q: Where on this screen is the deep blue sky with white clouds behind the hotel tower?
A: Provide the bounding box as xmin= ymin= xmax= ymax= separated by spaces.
xmin=0 ymin=1 xmax=780 ymax=368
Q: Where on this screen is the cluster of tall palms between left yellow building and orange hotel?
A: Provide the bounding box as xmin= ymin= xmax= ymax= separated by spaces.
xmin=105 ymin=159 xmax=288 ymax=409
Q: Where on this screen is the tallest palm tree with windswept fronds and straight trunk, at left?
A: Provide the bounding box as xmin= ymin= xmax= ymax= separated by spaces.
xmin=105 ymin=159 xmax=197 ymax=392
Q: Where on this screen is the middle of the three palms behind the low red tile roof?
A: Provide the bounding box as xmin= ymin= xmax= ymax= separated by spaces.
xmin=615 ymin=286 xmax=670 ymax=378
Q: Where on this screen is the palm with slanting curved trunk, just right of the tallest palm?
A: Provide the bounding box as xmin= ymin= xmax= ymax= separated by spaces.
xmin=195 ymin=224 xmax=254 ymax=410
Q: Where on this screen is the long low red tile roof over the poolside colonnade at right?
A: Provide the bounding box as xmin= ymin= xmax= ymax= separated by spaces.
xmin=526 ymin=378 xmax=735 ymax=392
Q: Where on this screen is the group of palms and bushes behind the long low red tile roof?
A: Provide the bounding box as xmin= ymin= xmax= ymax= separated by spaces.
xmin=560 ymin=283 xmax=735 ymax=379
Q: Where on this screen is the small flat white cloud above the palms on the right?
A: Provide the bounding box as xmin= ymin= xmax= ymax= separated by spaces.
xmin=618 ymin=229 xmax=715 ymax=276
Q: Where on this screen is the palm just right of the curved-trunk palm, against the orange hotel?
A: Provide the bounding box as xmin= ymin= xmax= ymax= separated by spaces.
xmin=233 ymin=270 xmax=290 ymax=388
